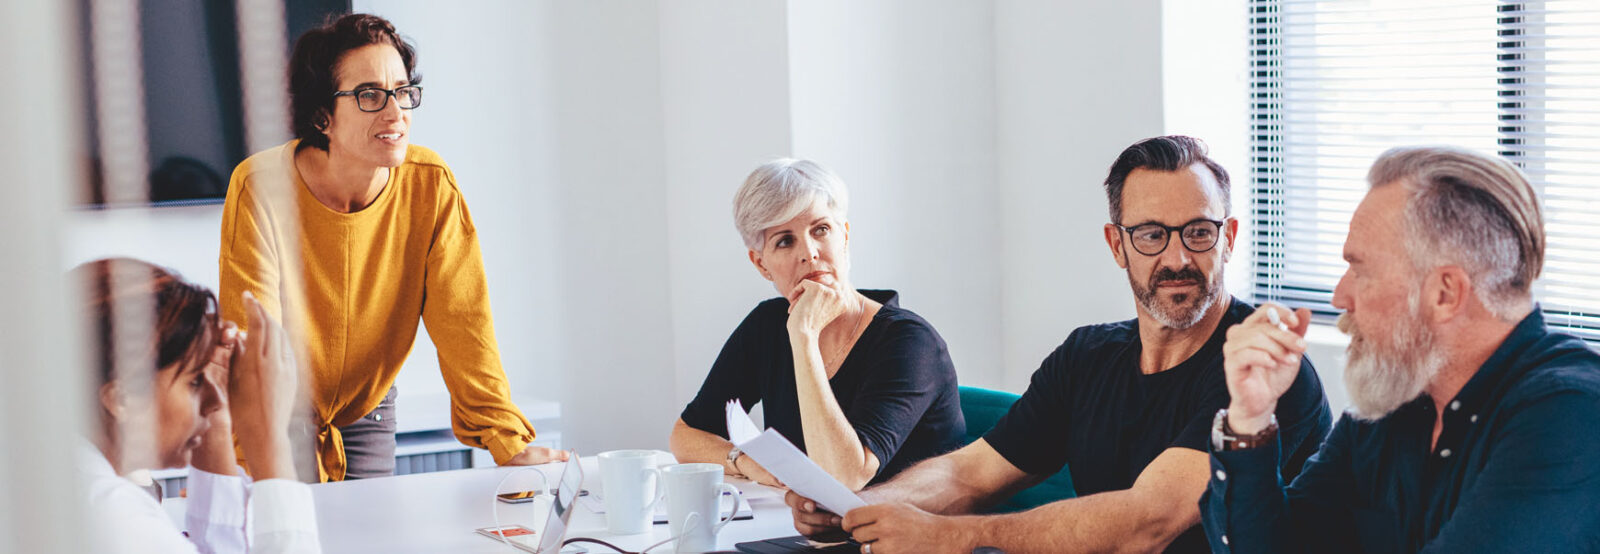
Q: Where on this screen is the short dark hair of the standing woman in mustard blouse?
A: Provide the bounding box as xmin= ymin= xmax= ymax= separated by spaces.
xmin=290 ymin=13 xmax=422 ymax=151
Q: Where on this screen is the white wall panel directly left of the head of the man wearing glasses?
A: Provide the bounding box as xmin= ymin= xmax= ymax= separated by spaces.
xmin=995 ymin=0 xmax=1162 ymax=385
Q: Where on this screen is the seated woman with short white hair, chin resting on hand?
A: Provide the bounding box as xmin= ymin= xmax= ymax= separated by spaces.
xmin=672 ymin=159 xmax=966 ymax=490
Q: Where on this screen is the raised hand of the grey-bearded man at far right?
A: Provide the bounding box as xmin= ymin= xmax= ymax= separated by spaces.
xmin=1222 ymin=303 xmax=1310 ymax=434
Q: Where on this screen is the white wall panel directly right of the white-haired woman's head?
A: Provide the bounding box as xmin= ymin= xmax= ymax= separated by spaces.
xmin=789 ymin=0 xmax=1005 ymax=386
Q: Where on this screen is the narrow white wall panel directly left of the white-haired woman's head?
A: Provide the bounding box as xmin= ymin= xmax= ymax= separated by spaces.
xmin=648 ymin=0 xmax=794 ymax=406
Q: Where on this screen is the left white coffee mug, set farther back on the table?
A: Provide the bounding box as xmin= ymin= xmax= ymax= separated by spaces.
xmin=597 ymin=450 xmax=664 ymax=535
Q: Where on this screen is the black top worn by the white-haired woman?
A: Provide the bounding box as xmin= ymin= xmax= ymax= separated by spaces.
xmin=682 ymin=290 xmax=966 ymax=484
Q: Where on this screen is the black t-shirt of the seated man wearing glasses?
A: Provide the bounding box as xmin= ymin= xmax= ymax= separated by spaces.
xmin=984 ymin=299 xmax=1333 ymax=552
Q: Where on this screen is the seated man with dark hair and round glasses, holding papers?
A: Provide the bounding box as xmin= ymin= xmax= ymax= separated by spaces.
xmin=786 ymin=136 xmax=1331 ymax=554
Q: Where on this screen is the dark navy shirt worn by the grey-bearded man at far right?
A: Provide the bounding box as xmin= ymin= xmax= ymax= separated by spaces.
xmin=1200 ymin=309 xmax=1600 ymax=552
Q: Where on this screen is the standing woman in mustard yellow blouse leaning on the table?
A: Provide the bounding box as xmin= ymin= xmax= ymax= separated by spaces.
xmin=219 ymin=14 xmax=565 ymax=480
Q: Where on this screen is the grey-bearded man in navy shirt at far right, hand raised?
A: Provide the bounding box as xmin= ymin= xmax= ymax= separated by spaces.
xmin=1200 ymin=147 xmax=1600 ymax=552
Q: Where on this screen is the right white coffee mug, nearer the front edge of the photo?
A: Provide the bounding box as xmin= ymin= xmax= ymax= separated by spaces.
xmin=661 ymin=464 xmax=739 ymax=552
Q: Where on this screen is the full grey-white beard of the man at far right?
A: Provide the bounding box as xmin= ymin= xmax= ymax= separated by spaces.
xmin=1339 ymin=290 xmax=1445 ymax=421
